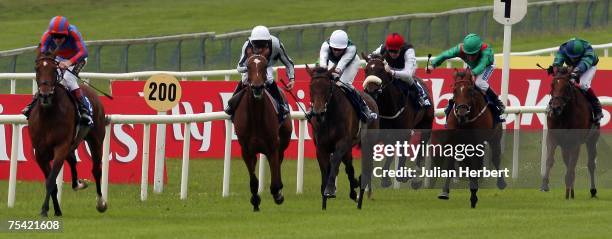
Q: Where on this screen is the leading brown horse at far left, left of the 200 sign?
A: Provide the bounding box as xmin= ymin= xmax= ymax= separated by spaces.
xmin=28 ymin=50 xmax=107 ymax=217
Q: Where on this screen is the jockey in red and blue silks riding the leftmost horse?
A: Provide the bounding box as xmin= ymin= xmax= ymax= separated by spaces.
xmin=22 ymin=16 xmax=93 ymax=127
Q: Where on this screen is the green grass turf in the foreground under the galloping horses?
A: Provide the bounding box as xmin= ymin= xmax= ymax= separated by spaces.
xmin=0 ymin=131 xmax=612 ymax=238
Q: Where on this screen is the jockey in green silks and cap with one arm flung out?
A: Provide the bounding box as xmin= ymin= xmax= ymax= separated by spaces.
xmin=428 ymin=33 xmax=506 ymax=121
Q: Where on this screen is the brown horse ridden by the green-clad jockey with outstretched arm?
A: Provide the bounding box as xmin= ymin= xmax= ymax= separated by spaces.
xmin=438 ymin=69 xmax=506 ymax=208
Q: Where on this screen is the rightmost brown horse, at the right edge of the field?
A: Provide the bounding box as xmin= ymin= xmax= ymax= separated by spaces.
xmin=541 ymin=67 xmax=600 ymax=199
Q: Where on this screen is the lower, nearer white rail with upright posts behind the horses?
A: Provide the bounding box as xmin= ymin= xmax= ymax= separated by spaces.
xmin=0 ymin=97 xmax=612 ymax=208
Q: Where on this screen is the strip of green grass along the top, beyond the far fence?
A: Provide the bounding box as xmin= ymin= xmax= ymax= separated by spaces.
xmin=0 ymin=0 xmax=504 ymax=50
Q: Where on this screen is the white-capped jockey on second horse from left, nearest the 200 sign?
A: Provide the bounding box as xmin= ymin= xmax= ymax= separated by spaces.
xmin=225 ymin=26 xmax=295 ymax=118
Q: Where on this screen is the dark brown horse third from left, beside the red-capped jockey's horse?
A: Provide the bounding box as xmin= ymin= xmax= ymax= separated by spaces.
xmin=306 ymin=65 xmax=378 ymax=209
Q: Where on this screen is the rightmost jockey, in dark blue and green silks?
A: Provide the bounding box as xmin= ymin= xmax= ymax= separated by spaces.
xmin=549 ymin=38 xmax=603 ymax=123
